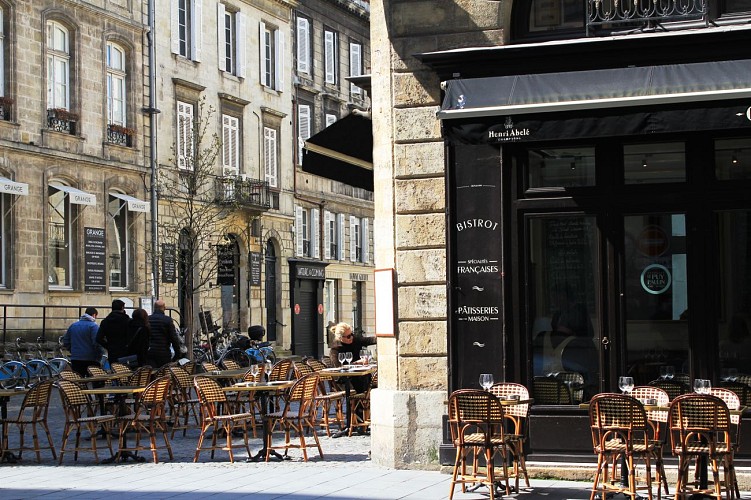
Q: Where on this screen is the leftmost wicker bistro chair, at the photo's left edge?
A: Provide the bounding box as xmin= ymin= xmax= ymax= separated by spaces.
xmin=0 ymin=379 xmax=57 ymax=462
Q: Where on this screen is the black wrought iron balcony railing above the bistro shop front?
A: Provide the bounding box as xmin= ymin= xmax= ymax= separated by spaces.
xmin=587 ymin=0 xmax=708 ymax=35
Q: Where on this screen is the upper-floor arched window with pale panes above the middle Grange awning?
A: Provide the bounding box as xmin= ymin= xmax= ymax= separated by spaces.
xmin=47 ymin=21 xmax=70 ymax=109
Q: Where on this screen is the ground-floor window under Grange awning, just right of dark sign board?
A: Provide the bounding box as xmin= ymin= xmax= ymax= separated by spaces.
xmin=106 ymin=193 xmax=133 ymax=288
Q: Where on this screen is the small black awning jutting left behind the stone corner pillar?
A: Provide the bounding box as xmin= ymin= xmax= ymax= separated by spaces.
xmin=302 ymin=114 xmax=373 ymax=191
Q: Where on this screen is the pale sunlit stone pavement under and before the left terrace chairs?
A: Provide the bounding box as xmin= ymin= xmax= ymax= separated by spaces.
xmin=0 ymin=389 xmax=751 ymax=500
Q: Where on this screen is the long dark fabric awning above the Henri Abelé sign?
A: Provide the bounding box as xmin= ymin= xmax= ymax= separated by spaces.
xmin=438 ymin=59 xmax=751 ymax=119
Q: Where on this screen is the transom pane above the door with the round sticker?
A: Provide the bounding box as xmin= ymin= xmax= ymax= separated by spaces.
xmin=623 ymin=142 xmax=686 ymax=184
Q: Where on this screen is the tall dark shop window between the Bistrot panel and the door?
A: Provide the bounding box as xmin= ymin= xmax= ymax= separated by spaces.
xmin=528 ymin=215 xmax=599 ymax=405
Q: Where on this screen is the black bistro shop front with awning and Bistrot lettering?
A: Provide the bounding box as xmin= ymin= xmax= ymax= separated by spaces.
xmin=420 ymin=29 xmax=751 ymax=460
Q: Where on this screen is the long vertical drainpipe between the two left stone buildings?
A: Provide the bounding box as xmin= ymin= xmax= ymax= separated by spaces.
xmin=144 ymin=0 xmax=159 ymax=299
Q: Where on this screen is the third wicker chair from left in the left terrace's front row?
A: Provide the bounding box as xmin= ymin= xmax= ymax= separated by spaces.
xmin=117 ymin=377 xmax=173 ymax=463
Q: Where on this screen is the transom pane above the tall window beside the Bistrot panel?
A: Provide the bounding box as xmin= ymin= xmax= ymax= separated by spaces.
xmin=529 ymin=147 xmax=595 ymax=189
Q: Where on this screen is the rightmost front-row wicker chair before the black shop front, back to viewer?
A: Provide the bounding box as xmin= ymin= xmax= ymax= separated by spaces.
xmin=668 ymin=394 xmax=735 ymax=500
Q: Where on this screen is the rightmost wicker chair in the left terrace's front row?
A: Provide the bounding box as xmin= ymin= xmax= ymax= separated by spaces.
xmin=263 ymin=373 xmax=323 ymax=462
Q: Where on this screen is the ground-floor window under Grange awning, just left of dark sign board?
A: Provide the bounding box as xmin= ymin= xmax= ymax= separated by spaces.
xmin=47 ymin=182 xmax=74 ymax=288
